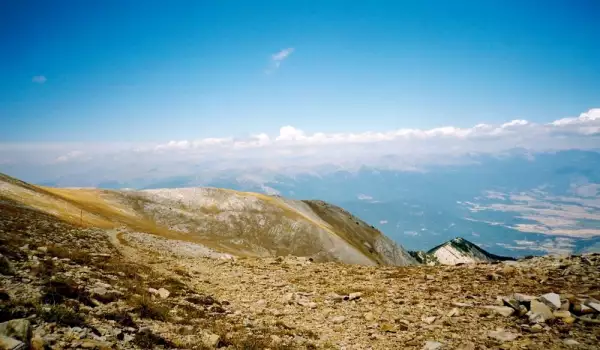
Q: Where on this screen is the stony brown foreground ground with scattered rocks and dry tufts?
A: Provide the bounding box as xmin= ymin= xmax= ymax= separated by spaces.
xmin=0 ymin=201 xmax=600 ymax=349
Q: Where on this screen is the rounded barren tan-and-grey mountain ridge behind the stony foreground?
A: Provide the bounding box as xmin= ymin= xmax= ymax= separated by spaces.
xmin=0 ymin=175 xmax=415 ymax=265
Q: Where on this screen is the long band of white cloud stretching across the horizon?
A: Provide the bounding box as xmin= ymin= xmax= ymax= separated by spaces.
xmin=0 ymin=108 xmax=600 ymax=186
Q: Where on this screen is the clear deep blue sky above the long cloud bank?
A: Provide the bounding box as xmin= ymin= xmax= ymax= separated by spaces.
xmin=0 ymin=0 xmax=600 ymax=143
